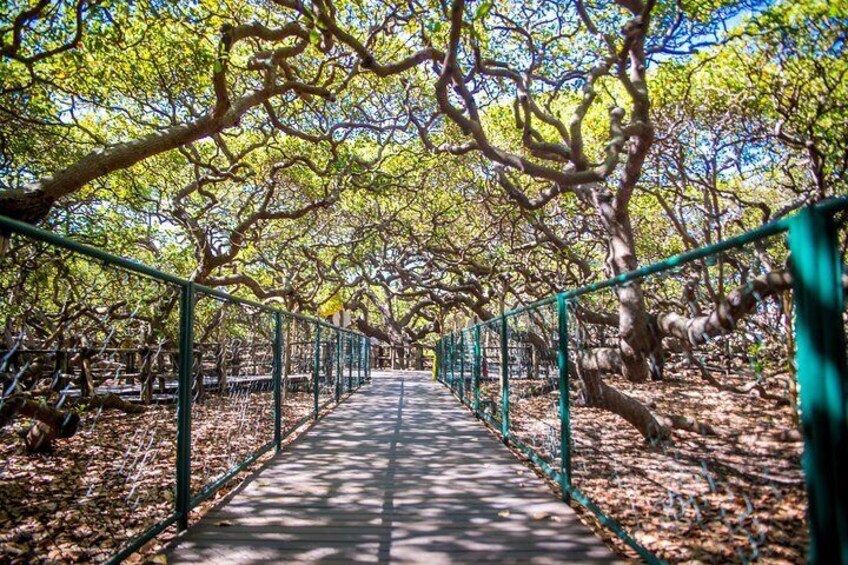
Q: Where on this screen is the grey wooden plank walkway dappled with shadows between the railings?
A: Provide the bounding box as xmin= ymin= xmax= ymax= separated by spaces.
xmin=167 ymin=372 xmax=616 ymax=565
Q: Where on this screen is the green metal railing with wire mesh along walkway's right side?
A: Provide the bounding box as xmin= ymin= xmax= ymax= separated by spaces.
xmin=436 ymin=199 xmax=848 ymax=564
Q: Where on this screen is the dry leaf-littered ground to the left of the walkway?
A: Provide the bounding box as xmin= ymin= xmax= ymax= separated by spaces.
xmin=0 ymin=391 xmax=338 ymax=564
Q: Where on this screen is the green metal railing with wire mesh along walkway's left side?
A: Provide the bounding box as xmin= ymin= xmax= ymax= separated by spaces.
xmin=0 ymin=216 xmax=371 ymax=563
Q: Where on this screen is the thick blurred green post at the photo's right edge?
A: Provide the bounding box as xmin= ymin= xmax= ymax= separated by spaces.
xmin=789 ymin=208 xmax=848 ymax=565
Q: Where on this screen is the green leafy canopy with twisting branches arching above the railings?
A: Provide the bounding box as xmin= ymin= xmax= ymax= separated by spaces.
xmin=0 ymin=0 xmax=848 ymax=392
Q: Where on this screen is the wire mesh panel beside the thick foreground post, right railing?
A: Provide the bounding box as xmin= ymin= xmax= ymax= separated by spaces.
xmin=568 ymin=228 xmax=807 ymax=562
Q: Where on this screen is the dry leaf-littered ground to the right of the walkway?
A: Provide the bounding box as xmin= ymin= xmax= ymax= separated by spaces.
xmin=510 ymin=372 xmax=808 ymax=563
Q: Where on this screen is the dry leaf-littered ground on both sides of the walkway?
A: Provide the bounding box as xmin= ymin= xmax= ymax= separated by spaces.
xmin=0 ymin=371 xmax=807 ymax=564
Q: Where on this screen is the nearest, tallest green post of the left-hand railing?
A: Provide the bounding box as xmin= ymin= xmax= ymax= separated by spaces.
xmin=176 ymin=282 xmax=194 ymax=531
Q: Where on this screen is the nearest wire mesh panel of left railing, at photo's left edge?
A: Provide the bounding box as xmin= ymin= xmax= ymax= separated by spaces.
xmin=0 ymin=235 xmax=179 ymax=562
